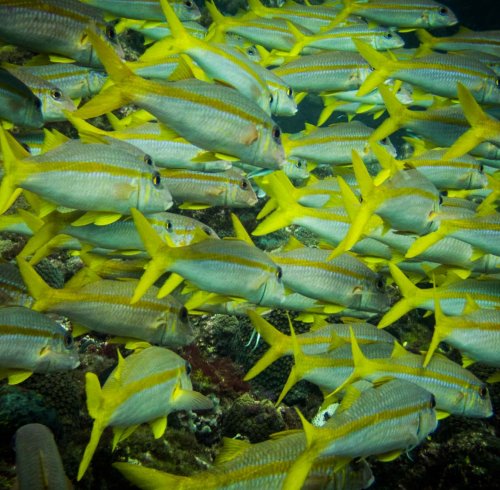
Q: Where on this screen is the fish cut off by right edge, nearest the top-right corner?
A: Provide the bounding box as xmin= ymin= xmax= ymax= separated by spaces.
xmin=415 ymin=26 xmax=500 ymax=57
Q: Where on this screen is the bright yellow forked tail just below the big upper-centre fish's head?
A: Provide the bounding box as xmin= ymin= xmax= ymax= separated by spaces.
xmin=252 ymin=170 xmax=303 ymax=236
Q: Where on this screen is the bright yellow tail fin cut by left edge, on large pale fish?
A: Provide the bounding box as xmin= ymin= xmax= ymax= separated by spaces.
xmin=0 ymin=126 xmax=29 ymax=214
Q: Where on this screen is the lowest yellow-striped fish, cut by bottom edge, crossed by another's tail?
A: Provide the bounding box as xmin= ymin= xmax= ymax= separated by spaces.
xmin=113 ymin=431 xmax=373 ymax=490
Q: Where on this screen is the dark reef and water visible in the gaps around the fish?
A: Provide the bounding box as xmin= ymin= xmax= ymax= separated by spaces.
xmin=0 ymin=0 xmax=500 ymax=490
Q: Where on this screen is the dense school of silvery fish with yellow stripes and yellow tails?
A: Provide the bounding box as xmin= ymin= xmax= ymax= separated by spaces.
xmin=0 ymin=0 xmax=500 ymax=490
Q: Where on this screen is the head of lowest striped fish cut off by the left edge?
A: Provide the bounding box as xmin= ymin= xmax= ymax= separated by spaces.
xmin=36 ymin=326 xmax=80 ymax=372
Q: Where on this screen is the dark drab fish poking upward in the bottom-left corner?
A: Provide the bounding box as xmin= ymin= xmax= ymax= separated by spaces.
xmin=15 ymin=423 xmax=73 ymax=490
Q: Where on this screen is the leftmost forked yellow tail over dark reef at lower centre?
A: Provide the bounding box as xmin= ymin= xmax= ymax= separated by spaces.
xmin=243 ymin=310 xmax=291 ymax=381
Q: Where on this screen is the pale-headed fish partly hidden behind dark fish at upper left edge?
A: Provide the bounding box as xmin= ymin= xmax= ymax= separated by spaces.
xmin=3 ymin=64 xmax=76 ymax=122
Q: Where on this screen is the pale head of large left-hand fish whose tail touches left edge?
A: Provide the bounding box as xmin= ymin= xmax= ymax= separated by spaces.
xmin=135 ymin=160 xmax=173 ymax=213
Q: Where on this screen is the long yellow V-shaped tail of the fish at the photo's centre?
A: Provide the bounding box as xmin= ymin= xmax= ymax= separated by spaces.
xmin=130 ymin=208 xmax=172 ymax=303
